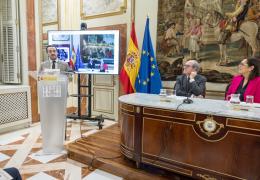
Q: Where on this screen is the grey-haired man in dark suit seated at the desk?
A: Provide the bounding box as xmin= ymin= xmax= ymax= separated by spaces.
xmin=174 ymin=60 xmax=206 ymax=97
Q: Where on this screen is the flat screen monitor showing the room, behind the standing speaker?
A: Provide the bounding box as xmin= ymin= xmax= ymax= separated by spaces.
xmin=48 ymin=30 xmax=119 ymax=74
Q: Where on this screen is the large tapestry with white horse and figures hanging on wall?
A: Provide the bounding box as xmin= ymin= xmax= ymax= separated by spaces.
xmin=157 ymin=0 xmax=260 ymax=83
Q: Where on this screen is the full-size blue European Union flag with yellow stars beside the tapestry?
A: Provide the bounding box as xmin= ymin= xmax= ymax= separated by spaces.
xmin=135 ymin=18 xmax=162 ymax=94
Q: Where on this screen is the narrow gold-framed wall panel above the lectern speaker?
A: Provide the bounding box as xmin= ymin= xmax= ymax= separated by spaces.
xmin=41 ymin=0 xmax=60 ymax=26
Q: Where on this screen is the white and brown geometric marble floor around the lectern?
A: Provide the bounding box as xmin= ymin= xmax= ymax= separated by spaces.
xmin=0 ymin=120 xmax=122 ymax=180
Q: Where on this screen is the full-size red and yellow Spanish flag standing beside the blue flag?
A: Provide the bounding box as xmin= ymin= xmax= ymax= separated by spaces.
xmin=120 ymin=21 xmax=140 ymax=94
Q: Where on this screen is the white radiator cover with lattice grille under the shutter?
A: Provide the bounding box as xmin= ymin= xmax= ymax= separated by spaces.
xmin=0 ymin=85 xmax=31 ymax=132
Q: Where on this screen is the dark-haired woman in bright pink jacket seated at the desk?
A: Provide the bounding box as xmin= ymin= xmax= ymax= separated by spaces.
xmin=225 ymin=57 xmax=260 ymax=103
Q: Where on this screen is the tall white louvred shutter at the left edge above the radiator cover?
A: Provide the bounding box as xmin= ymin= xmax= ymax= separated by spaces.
xmin=0 ymin=0 xmax=21 ymax=84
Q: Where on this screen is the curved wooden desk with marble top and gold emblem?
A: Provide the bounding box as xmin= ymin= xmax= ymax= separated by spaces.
xmin=119 ymin=94 xmax=260 ymax=180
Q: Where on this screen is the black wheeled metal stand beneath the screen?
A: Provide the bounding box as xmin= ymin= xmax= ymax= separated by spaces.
xmin=65 ymin=74 xmax=104 ymax=138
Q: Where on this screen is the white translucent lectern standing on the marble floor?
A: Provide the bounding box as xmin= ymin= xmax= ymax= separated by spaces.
xmin=38 ymin=71 xmax=68 ymax=154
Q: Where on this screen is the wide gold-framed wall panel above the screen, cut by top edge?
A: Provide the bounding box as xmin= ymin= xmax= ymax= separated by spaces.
xmin=80 ymin=0 xmax=127 ymax=19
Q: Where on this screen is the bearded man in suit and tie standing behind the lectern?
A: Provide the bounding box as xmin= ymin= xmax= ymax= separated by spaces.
xmin=40 ymin=45 xmax=71 ymax=72
